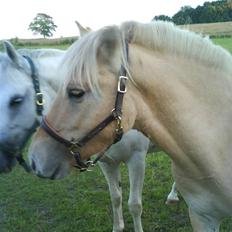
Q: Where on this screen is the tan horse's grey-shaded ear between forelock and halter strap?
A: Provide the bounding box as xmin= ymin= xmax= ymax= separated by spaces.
xmin=97 ymin=26 xmax=122 ymax=70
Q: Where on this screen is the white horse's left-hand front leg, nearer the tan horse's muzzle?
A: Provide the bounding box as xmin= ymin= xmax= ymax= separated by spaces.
xmin=99 ymin=162 xmax=124 ymax=232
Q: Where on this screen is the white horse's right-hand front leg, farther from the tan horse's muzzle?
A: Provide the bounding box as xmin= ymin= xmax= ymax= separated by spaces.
xmin=126 ymin=151 xmax=146 ymax=232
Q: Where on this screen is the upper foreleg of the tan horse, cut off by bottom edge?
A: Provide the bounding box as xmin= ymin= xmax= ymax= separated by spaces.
xmin=189 ymin=209 xmax=220 ymax=232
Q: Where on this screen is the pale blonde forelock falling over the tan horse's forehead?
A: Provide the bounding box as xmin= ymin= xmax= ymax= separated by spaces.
xmin=62 ymin=26 xmax=128 ymax=96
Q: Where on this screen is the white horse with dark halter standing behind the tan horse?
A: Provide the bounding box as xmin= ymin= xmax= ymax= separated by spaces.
xmin=0 ymin=42 xmax=178 ymax=231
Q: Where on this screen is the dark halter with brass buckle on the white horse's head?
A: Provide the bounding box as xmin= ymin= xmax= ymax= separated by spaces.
xmin=2 ymin=56 xmax=44 ymax=172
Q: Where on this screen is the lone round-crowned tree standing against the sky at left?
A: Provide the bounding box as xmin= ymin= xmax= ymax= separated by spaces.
xmin=28 ymin=13 xmax=57 ymax=38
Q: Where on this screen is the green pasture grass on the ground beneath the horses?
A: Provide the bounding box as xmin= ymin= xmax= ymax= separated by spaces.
xmin=0 ymin=38 xmax=232 ymax=232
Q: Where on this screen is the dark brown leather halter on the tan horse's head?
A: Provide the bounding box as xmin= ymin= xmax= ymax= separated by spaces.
xmin=41 ymin=43 xmax=128 ymax=172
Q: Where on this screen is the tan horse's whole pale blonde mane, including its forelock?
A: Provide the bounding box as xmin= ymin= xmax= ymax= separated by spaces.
xmin=63 ymin=21 xmax=232 ymax=91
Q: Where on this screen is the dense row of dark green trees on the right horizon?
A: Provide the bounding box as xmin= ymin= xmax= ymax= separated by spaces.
xmin=153 ymin=0 xmax=232 ymax=25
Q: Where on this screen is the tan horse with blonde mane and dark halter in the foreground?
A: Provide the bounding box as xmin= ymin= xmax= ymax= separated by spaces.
xmin=29 ymin=21 xmax=232 ymax=232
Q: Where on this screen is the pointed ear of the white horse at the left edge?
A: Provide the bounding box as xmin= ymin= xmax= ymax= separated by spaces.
xmin=3 ymin=41 xmax=25 ymax=67
